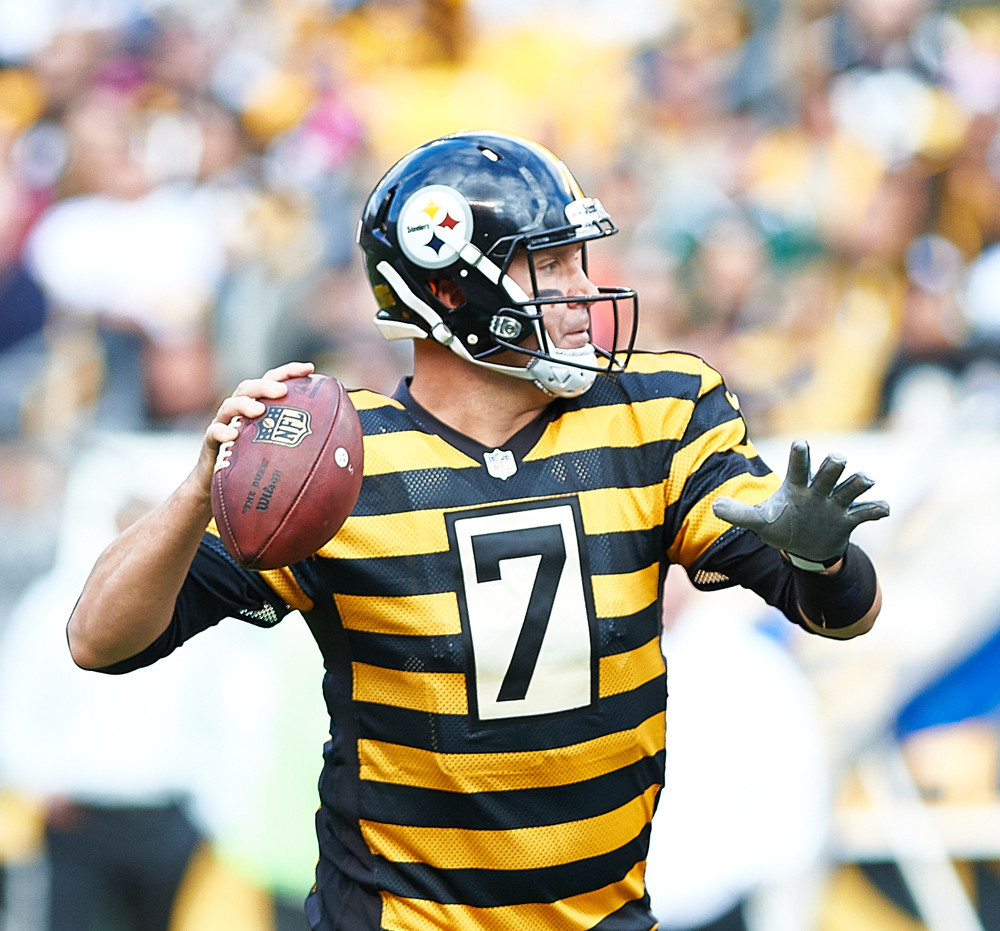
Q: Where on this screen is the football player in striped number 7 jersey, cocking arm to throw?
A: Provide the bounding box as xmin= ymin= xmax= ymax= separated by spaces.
xmin=68 ymin=132 xmax=888 ymax=931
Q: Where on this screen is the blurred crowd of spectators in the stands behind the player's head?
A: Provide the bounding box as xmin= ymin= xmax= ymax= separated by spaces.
xmin=0 ymin=0 xmax=1000 ymax=931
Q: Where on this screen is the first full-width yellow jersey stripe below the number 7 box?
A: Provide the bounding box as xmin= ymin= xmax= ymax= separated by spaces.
xmin=358 ymin=711 xmax=666 ymax=792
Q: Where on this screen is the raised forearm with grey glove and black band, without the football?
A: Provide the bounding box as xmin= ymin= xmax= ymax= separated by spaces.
xmin=712 ymin=440 xmax=889 ymax=640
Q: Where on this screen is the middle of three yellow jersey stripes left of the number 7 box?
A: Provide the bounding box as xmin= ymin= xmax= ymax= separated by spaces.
xmin=334 ymin=592 xmax=462 ymax=637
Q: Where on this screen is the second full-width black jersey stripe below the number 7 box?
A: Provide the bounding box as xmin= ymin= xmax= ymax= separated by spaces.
xmin=361 ymin=750 xmax=665 ymax=831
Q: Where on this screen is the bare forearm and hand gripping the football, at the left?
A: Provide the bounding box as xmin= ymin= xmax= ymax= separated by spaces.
xmin=66 ymin=362 xmax=313 ymax=669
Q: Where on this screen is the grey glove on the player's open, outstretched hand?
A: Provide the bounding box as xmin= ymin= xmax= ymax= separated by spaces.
xmin=712 ymin=440 xmax=889 ymax=568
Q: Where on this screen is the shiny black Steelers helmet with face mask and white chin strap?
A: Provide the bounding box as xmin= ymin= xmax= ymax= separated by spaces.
xmin=357 ymin=132 xmax=638 ymax=397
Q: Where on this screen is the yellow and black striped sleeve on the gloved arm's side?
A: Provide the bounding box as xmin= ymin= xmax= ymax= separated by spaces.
xmin=665 ymin=360 xmax=781 ymax=570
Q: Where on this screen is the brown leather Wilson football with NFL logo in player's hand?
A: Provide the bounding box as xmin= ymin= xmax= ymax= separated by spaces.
xmin=212 ymin=375 xmax=364 ymax=569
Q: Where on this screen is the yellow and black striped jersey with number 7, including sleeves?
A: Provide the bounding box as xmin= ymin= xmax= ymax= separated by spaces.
xmin=111 ymin=353 xmax=778 ymax=931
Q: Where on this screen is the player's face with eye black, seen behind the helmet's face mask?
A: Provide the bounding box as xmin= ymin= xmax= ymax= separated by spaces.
xmin=508 ymin=243 xmax=597 ymax=349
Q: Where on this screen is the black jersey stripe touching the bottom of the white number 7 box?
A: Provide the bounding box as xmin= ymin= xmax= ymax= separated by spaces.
xmin=354 ymin=675 xmax=667 ymax=754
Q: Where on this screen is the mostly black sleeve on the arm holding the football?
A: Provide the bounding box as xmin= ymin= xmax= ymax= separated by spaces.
xmin=98 ymin=533 xmax=304 ymax=674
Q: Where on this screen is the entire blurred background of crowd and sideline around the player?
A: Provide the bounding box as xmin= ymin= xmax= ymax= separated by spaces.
xmin=0 ymin=0 xmax=1000 ymax=931
